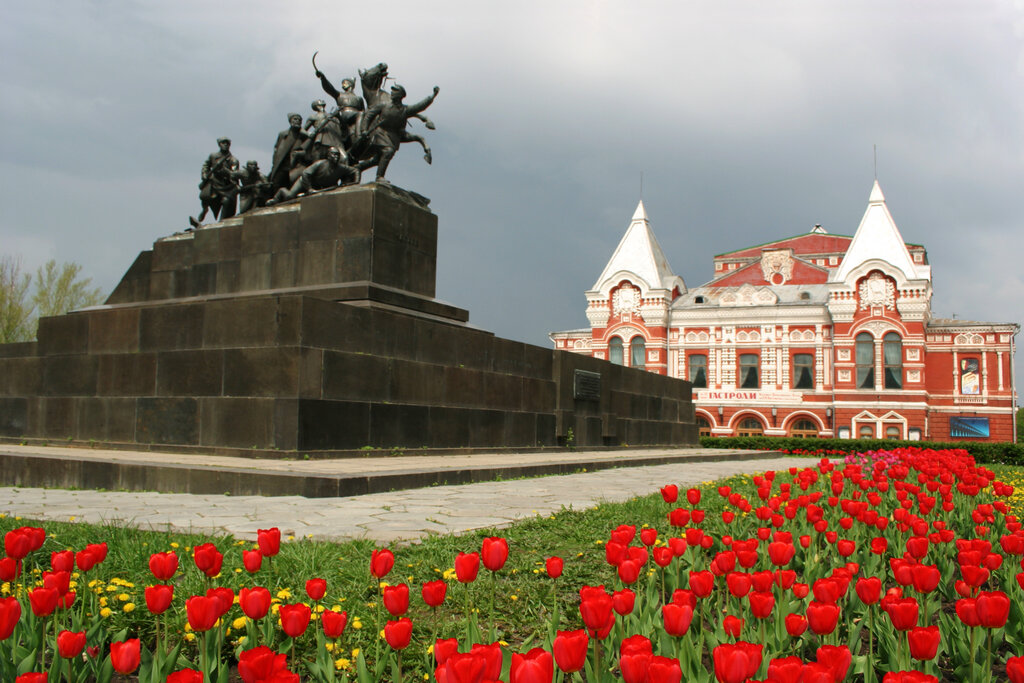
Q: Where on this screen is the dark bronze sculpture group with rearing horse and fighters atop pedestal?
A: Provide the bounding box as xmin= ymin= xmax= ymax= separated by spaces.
xmin=188 ymin=53 xmax=438 ymax=228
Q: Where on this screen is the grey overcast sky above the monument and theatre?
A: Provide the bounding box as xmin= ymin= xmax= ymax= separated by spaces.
xmin=0 ymin=0 xmax=1024 ymax=395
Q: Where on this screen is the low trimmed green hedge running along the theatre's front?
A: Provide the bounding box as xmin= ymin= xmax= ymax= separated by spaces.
xmin=700 ymin=436 xmax=1024 ymax=465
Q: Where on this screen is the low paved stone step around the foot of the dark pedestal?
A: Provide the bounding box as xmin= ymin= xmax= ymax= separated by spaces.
xmin=0 ymin=443 xmax=779 ymax=498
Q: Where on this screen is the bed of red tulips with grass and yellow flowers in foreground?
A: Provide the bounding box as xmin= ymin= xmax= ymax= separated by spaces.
xmin=0 ymin=447 xmax=1024 ymax=683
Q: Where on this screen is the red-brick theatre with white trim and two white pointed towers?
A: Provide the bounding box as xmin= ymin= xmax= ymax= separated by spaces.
xmin=551 ymin=182 xmax=1020 ymax=441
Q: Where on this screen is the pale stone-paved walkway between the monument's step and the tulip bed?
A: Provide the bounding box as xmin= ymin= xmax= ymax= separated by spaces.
xmin=0 ymin=455 xmax=816 ymax=542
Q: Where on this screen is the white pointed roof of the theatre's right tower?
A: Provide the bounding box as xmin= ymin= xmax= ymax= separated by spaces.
xmin=831 ymin=180 xmax=931 ymax=282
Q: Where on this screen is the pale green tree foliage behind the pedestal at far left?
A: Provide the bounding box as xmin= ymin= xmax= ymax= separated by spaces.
xmin=0 ymin=256 xmax=103 ymax=343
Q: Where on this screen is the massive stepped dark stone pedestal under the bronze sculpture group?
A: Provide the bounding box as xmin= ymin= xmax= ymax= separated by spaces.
xmin=0 ymin=60 xmax=696 ymax=454
